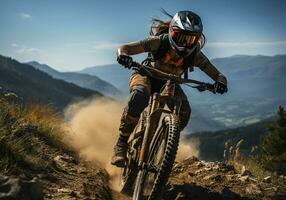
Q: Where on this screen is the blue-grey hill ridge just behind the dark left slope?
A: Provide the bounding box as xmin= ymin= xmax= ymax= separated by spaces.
xmin=27 ymin=61 xmax=121 ymax=97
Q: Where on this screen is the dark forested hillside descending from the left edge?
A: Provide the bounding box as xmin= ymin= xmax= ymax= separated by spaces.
xmin=0 ymin=55 xmax=103 ymax=109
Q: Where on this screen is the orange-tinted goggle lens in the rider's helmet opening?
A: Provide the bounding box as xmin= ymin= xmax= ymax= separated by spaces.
xmin=171 ymin=30 xmax=201 ymax=47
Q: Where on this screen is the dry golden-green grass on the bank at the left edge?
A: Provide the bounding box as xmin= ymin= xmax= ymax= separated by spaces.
xmin=0 ymin=96 xmax=69 ymax=174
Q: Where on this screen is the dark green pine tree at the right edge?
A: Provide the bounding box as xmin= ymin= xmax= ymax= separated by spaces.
xmin=261 ymin=106 xmax=286 ymax=174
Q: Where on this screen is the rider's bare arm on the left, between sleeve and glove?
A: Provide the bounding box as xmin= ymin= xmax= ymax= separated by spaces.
xmin=117 ymin=36 xmax=161 ymax=56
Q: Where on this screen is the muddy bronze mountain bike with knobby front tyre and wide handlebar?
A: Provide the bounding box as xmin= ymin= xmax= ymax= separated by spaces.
xmin=121 ymin=62 xmax=214 ymax=200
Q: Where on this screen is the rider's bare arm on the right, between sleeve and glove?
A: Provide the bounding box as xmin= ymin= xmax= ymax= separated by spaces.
xmin=195 ymin=51 xmax=227 ymax=85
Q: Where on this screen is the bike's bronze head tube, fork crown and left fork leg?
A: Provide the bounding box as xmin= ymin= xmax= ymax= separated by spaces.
xmin=138 ymin=81 xmax=182 ymax=169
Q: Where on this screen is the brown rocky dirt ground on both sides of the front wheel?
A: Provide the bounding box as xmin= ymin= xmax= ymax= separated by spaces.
xmin=0 ymin=152 xmax=286 ymax=200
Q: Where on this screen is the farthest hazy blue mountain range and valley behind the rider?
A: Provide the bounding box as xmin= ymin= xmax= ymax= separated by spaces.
xmin=80 ymin=55 xmax=286 ymax=132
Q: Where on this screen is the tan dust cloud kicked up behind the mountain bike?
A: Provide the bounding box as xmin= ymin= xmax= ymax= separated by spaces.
xmin=65 ymin=99 xmax=198 ymax=190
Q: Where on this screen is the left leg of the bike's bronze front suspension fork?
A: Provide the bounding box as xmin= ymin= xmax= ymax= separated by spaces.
xmin=139 ymin=93 xmax=161 ymax=168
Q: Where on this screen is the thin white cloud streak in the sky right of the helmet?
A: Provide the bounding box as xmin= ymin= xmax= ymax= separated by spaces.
xmin=206 ymin=41 xmax=286 ymax=48
